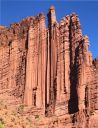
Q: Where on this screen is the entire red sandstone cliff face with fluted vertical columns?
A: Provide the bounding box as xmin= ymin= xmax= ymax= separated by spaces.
xmin=0 ymin=6 xmax=98 ymax=128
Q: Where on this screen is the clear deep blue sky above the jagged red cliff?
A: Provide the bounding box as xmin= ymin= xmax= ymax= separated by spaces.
xmin=0 ymin=0 xmax=98 ymax=58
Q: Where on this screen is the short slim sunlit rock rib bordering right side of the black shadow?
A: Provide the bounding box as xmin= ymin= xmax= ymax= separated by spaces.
xmin=77 ymin=45 xmax=86 ymax=110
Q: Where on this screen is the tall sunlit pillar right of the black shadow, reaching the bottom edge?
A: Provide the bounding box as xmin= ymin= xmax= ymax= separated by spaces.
xmin=77 ymin=36 xmax=91 ymax=127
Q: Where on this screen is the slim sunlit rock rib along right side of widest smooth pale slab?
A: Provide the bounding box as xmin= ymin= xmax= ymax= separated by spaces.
xmin=34 ymin=16 xmax=43 ymax=108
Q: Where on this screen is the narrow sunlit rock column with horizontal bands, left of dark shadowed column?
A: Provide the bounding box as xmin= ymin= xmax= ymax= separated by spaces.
xmin=64 ymin=16 xmax=70 ymax=101
